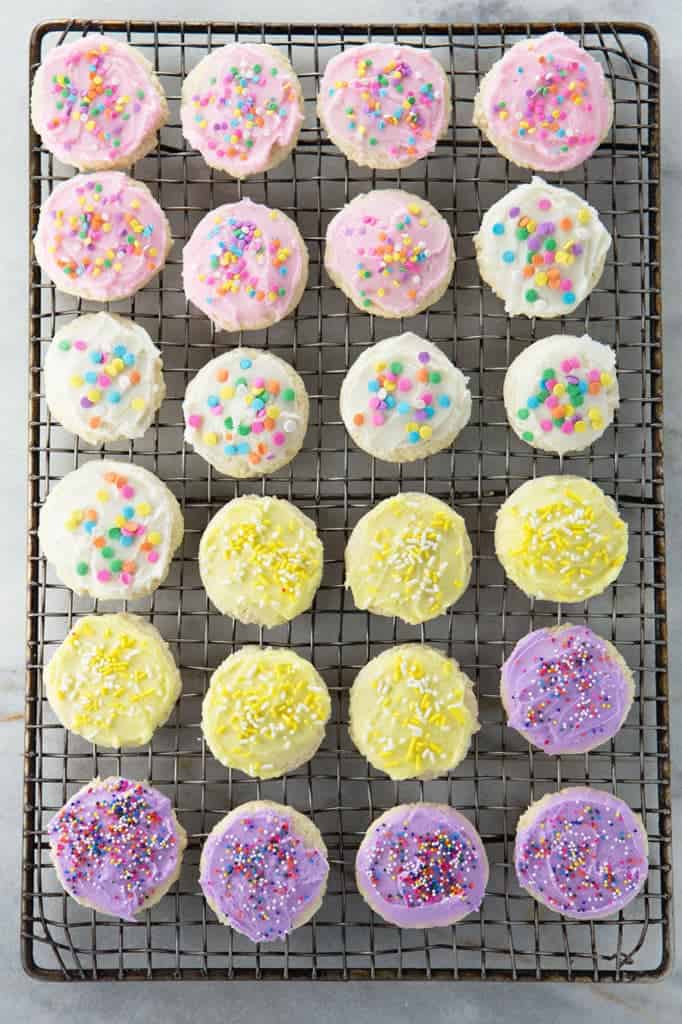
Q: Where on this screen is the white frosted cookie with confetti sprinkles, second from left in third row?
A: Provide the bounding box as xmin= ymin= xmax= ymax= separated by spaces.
xmin=182 ymin=348 xmax=308 ymax=477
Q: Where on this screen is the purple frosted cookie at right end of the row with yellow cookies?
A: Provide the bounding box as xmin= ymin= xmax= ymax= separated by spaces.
xmin=500 ymin=623 xmax=635 ymax=754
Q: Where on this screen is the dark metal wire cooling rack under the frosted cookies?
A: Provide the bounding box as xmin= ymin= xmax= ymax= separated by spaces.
xmin=22 ymin=22 xmax=672 ymax=981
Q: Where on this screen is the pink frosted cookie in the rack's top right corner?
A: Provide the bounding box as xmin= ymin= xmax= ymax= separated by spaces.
xmin=473 ymin=32 xmax=613 ymax=173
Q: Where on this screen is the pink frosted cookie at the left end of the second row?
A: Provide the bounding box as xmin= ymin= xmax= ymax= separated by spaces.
xmin=33 ymin=171 xmax=173 ymax=302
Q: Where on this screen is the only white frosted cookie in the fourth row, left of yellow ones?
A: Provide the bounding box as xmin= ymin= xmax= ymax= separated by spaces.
xmin=38 ymin=459 xmax=184 ymax=600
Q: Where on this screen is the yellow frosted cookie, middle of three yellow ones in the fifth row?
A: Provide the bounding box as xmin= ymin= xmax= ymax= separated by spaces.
xmin=202 ymin=647 xmax=332 ymax=778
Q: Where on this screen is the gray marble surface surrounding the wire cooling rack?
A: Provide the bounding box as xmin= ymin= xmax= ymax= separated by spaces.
xmin=0 ymin=0 xmax=682 ymax=1024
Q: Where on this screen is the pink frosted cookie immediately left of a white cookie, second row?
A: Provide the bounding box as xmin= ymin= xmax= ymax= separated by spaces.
xmin=325 ymin=188 xmax=455 ymax=318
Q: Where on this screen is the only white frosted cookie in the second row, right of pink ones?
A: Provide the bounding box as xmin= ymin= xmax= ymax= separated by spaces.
xmin=474 ymin=177 xmax=611 ymax=319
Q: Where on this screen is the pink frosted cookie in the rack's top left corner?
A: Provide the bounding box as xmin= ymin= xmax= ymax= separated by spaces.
xmin=31 ymin=36 xmax=168 ymax=171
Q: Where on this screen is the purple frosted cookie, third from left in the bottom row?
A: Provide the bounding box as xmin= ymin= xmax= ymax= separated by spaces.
xmin=355 ymin=804 xmax=488 ymax=928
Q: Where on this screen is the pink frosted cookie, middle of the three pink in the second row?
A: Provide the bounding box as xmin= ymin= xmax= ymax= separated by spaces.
xmin=182 ymin=199 xmax=308 ymax=331
